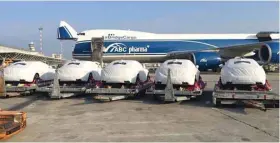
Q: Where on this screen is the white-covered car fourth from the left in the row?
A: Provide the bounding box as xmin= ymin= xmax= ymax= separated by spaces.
xmin=155 ymin=59 xmax=200 ymax=85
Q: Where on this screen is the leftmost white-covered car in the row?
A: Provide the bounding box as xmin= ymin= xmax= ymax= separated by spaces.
xmin=4 ymin=61 xmax=55 ymax=83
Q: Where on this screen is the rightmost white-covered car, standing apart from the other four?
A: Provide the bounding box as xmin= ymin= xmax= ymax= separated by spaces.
xmin=221 ymin=58 xmax=266 ymax=85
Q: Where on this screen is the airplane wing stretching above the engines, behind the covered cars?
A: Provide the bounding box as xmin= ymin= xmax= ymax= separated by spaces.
xmin=167 ymin=42 xmax=265 ymax=58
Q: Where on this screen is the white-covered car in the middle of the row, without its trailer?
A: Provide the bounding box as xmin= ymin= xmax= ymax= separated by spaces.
xmin=101 ymin=60 xmax=148 ymax=84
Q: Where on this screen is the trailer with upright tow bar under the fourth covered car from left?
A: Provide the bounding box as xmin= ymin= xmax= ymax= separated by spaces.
xmin=146 ymin=69 xmax=207 ymax=103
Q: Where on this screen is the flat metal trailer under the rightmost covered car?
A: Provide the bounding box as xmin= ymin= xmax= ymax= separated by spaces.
xmin=212 ymin=84 xmax=279 ymax=111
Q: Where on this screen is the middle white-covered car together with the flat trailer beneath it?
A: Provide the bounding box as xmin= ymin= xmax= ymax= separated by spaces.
xmin=86 ymin=60 xmax=152 ymax=101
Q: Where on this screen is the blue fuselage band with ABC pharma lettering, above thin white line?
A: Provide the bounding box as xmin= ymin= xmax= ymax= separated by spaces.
xmin=73 ymin=39 xmax=258 ymax=55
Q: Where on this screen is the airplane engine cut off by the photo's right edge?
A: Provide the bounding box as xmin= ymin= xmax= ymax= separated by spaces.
xmin=258 ymin=41 xmax=279 ymax=64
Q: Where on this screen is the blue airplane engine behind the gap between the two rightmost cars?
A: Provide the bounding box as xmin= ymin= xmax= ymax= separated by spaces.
xmin=189 ymin=52 xmax=222 ymax=71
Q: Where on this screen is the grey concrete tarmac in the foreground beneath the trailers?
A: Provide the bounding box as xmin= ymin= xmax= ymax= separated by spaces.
xmin=0 ymin=74 xmax=279 ymax=142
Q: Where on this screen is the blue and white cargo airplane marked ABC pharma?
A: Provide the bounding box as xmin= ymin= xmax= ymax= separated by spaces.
xmin=57 ymin=21 xmax=280 ymax=70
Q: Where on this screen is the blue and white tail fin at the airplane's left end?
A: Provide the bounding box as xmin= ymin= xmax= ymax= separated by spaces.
xmin=57 ymin=21 xmax=78 ymax=40
